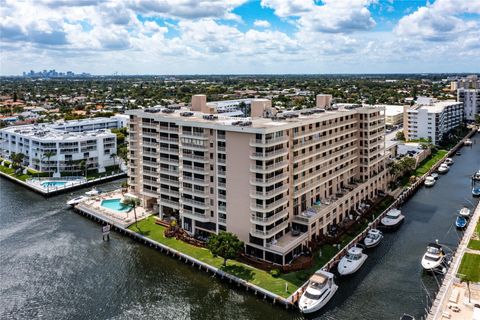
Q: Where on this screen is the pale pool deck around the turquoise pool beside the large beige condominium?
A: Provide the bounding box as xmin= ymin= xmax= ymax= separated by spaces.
xmin=75 ymin=190 xmax=152 ymax=228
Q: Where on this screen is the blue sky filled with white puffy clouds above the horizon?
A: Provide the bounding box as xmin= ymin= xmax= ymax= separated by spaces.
xmin=0 ymin=0 xmax=480 ymax=75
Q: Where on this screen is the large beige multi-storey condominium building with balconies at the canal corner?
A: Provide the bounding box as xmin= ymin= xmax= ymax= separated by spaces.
xmin=127 ymin=97 xmax=387 ymax=264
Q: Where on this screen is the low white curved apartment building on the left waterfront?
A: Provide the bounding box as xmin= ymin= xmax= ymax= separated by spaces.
xmin=0 ymin=124 xmax=117 ymax=177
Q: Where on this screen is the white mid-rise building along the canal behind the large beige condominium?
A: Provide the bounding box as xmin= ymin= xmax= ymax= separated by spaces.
xmin=403 ymin=97 xmax=463 ymax=145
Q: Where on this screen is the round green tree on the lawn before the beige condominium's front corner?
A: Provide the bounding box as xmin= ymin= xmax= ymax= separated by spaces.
xmin=207 ymin=231 xmax=244 ymax=266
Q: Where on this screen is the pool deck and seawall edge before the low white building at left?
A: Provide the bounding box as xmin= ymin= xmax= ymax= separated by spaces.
xmin=0 ymin=171 xmax=127 ymax=198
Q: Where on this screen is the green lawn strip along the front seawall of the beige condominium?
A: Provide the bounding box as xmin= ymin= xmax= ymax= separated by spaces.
xmin=129 ymin=216 xmax=300 ymax=298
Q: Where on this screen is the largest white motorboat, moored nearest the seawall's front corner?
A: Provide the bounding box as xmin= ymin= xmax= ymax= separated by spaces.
xmin=298 ymin=270 xmax=338 ymax=313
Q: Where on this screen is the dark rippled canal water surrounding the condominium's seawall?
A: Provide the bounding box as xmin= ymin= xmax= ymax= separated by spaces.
xmin=0 ymin=135 xmax=480 ymax=320
